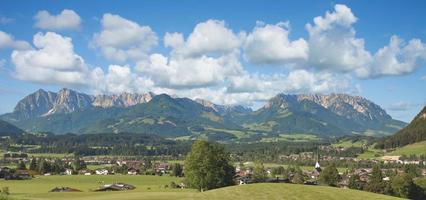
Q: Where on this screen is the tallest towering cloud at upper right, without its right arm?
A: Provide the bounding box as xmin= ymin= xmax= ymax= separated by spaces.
xmin=306 ymin=4 xmax=372 ymax=74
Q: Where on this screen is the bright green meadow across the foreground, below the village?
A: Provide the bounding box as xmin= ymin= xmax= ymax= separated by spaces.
xmin=0 ymin=175 xmax=398 ymax=200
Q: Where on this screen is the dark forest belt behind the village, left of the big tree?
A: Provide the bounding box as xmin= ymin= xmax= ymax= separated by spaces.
xmin=1 ymin=133 xmax=191 ymax=157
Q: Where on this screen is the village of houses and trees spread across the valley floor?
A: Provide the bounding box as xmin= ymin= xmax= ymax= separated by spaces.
xmin=0 ymin=148 xmax=426 ymax=192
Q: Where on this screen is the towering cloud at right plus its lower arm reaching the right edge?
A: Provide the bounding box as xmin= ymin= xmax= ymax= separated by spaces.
xmin=306 ymin=4 xmax=426 ymax=79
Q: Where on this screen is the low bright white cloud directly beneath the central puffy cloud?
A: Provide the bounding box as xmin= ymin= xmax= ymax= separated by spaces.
xmin=137 ymin=51 xmax=242 ymax=88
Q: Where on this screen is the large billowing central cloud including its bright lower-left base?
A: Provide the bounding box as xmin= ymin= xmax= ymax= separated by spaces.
xmin=137 ymin=20 xmax=243 ymax=88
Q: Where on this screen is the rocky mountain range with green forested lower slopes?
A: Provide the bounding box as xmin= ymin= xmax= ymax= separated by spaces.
xmin=0 ymin=88 xmax=406 ymax=140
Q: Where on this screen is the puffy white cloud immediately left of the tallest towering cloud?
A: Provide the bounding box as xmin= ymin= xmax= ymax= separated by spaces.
xmin=244 ymin=22 xmax=309 ymax=64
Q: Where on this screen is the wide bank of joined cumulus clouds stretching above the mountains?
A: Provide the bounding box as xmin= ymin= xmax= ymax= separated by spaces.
xmin=8 ymin=4 xmax=426 ymax=108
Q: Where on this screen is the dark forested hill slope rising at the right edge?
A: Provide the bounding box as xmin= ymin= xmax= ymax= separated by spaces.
xmin=379 ymin=106 xmax=426 ymax=148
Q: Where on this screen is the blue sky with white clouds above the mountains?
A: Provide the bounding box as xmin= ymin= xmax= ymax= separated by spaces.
xmin=0 ymin=0 xmax=426 ymax=122
